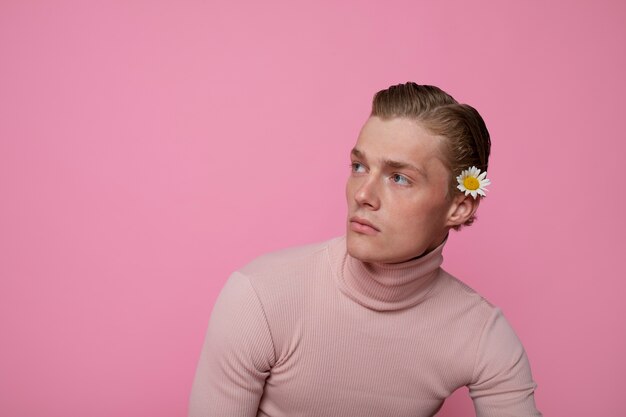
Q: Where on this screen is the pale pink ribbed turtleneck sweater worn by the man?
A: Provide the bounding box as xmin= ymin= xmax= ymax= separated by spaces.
xmin=189 ymin=237 xmax=541 ymax=417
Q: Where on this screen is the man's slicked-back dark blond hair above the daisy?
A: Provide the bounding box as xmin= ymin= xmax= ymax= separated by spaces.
xmin=371 ymin=82 xmax=491 ymax=230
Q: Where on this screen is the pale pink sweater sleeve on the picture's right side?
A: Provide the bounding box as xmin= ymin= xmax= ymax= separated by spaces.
xmin=468 ymin=308 xmax=541 ymax=417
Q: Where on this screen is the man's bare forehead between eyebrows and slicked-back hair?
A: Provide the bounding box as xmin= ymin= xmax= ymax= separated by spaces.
xmin=355 ymin=116 xmax=445 ymax=168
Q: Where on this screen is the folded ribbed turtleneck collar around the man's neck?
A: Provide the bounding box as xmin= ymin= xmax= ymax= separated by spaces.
xmin=336 ymin=237 xmax=447 ymax=311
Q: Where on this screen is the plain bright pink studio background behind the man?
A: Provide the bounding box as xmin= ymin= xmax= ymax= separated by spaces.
xmin=0 ymin=0 xmax=626 ymax=417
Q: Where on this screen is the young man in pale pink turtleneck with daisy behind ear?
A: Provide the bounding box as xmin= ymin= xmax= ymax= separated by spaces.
xmin=189 ymin=83 xmax=541 ymax=417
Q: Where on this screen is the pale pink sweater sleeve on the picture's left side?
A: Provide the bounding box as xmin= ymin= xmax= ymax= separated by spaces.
xmin=189 ymin=272 xmax=275 ymax=417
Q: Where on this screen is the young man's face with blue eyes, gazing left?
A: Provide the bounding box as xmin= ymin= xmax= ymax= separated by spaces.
xmin=346 ymin=117 xmax=452 ymax=263
